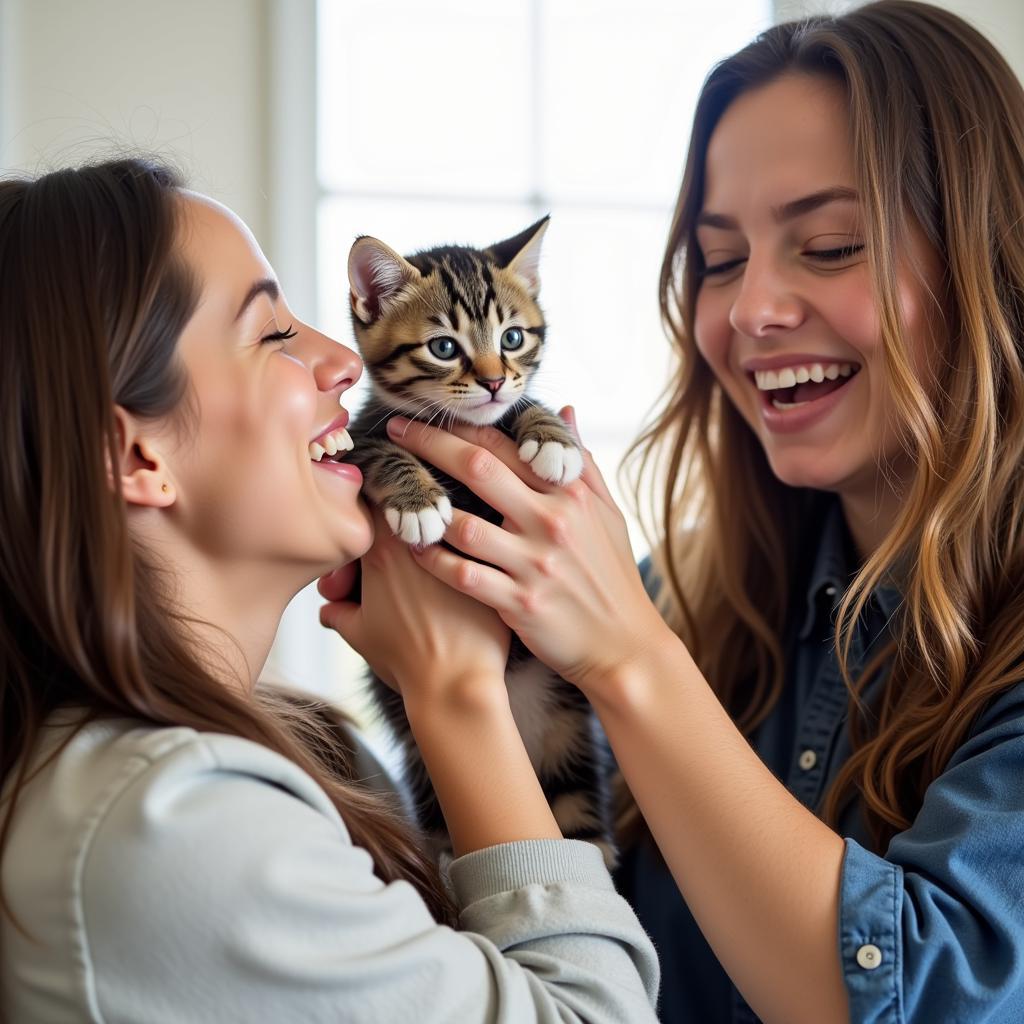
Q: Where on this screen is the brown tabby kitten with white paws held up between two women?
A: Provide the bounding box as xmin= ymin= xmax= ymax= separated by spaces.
xmin=348 ymin=217 xmax=614 ymax=865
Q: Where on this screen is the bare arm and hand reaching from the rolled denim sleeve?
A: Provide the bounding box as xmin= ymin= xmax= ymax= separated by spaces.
xmin=385 ymin=413 xmax=848 ymax=1024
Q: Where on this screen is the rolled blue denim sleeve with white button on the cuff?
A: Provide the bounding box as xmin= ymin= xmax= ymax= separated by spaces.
xmin=839 ymin=686 xmax=1024 ymax=1024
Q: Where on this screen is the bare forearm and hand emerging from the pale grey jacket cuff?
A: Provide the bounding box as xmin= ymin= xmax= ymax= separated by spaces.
xmin=319 ymin=512 xmax=561 ymax=855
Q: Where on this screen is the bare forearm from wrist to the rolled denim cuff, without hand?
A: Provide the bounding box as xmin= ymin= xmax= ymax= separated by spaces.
xmin=587 ymin=637 xmax=848 ymax=1024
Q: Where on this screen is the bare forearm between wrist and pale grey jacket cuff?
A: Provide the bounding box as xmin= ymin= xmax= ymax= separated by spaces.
xmin=406 ymin=679 xmax=561 ymax=856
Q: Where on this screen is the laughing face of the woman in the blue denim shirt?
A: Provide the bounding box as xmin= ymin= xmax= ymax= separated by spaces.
xmin=695 ymin=74 xmax=939 ymax=495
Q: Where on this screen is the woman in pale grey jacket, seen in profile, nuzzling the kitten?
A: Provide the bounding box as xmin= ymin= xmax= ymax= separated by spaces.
xmin=0 ymin=160 xmax=657 ymax=1024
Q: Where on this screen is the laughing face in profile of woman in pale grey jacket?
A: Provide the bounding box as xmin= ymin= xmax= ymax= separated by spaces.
xmin=169 ymin=194 xmax=373 ymax=579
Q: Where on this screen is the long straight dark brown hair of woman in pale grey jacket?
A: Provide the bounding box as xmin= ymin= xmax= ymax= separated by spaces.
xmin=0 ymin=159 xmax=455 ymax=924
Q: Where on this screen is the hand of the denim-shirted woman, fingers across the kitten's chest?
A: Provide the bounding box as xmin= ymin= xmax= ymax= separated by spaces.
xmin=391 ymin=407 xmax=673 ymax=691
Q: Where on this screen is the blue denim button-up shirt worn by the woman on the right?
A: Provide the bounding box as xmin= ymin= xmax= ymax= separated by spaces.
xmin=616 ymin=504 xmax=1024 ymax=1024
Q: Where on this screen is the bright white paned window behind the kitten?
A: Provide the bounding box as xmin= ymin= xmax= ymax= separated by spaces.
xmin=275 ymin=0 xmax=771 ymax=729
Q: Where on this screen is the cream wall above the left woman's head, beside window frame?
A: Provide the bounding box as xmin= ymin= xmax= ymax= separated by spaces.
xmin=0 ymin=0 xmax=269 ymax=249
